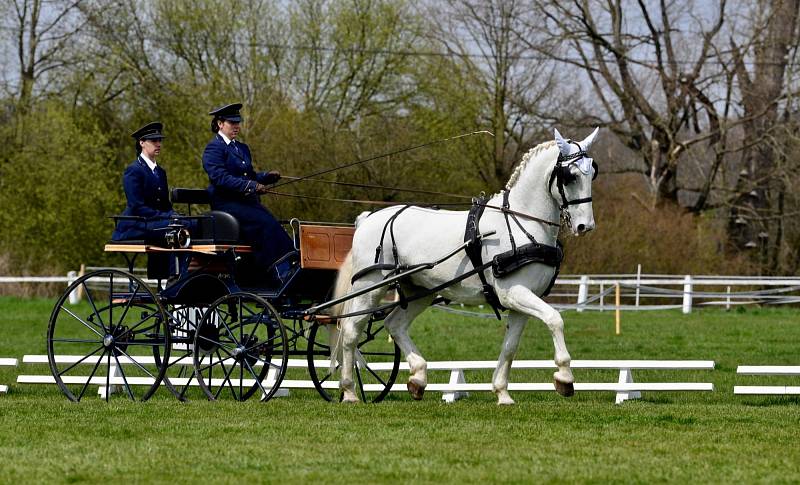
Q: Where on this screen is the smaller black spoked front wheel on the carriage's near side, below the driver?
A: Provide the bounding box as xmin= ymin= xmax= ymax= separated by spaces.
xmin=193 ymin=293 xmax=289 ymax=401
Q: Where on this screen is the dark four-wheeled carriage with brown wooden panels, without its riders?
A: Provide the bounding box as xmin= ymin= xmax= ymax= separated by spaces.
xmin=47 ymin=189 xmax=400 ymax=402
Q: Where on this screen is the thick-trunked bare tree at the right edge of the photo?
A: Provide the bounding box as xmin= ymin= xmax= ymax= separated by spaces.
xmin=729 ymin=0 xmax=800 ymax=272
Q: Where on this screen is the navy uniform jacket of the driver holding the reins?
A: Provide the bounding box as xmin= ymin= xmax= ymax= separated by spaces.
xmin=203 ymin=135 xmax=277 ymax=206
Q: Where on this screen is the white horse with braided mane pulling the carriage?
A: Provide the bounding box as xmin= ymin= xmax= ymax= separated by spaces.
xmin=332 ymin=129 xmax=598 ymax=404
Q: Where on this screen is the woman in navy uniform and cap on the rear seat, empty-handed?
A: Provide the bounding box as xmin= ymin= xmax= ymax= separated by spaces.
xmin=111 ymin=121 xmax=174 ymax=241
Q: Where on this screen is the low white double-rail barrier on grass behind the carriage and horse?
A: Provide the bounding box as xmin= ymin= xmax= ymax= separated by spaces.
xmin=17 ymin=355 xmax=714 ymax=404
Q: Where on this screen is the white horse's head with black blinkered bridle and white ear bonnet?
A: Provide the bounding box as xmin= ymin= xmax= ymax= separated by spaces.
xmin=548 ymin=128 xmax=599 ymax=235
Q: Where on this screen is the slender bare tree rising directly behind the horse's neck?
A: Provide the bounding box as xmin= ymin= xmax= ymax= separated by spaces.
xmin=431 ymin=0 xmax=558 ymax=185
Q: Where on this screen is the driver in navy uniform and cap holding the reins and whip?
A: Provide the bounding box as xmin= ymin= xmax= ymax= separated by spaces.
xmin=203 ymin=103 xmax=295 ymax=280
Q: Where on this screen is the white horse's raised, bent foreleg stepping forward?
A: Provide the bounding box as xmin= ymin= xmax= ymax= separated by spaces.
xmin=502 ymin=285 xmax=575 ymax=397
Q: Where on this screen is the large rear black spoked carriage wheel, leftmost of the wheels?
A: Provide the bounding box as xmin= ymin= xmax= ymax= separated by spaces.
xmin=47 ymin=269 xmax=170 ymax=402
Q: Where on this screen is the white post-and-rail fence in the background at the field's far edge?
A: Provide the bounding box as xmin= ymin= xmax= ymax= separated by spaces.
xmin=0 ymin=267 xmax=800 ymax=313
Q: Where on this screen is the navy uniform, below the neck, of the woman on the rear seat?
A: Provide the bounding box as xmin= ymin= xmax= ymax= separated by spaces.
xmin=111 ymin=157 xmax=173 ymax=241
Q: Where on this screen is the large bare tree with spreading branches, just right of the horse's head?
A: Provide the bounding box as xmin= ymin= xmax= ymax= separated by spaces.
xmin=522 ymin=0 xmax=731 ymax=209
